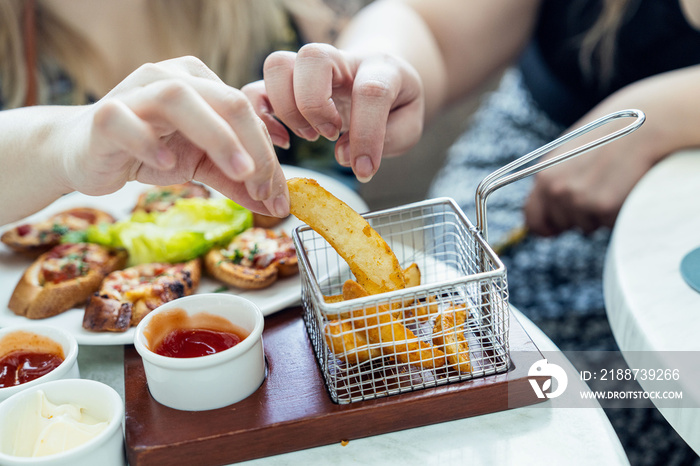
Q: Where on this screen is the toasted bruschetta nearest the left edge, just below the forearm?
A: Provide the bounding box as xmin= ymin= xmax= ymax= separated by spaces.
xmin=0 ymin=207 xmax=114 ymax=253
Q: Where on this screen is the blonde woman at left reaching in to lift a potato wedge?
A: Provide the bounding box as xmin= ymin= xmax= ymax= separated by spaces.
xmin=0 ymin=0 xmax=370 ymax=225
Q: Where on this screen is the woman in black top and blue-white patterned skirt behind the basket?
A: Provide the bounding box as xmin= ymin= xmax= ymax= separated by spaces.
xmin=248 ymin=0 xmax=700 ymax=348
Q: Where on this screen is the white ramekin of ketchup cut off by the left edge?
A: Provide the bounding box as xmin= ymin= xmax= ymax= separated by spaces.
xmin=0 ymin=324 xmax=80 ymax=401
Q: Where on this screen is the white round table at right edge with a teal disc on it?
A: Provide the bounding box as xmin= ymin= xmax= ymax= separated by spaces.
xmin=604 ymin=150 xmax=700 ymax=453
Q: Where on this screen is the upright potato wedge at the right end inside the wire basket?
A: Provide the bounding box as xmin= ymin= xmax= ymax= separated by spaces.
xmin=433 ymin=307 xmax=472 ymax=373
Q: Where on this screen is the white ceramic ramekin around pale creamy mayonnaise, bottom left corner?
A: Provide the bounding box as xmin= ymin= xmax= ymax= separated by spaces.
xmin=0 ymin=379 xmax=126 ymax=466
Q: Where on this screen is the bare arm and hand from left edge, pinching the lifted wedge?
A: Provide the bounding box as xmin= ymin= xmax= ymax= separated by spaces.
xmin=0 ymin=57 xmax=289 ymax=225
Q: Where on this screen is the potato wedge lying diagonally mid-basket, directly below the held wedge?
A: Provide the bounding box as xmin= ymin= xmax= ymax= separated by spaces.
xmin=343 ymin=280 xmax=445 ymax=369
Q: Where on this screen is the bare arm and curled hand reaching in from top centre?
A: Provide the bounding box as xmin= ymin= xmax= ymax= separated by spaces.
xmin=252 ymin=0 xmax=538 ymax=181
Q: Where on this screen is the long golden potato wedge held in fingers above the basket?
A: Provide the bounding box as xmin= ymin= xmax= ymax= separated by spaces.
xmin=287 ymin=178 xmax=406 ymax=294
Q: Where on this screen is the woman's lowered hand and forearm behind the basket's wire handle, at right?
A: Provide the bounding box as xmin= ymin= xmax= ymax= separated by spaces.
xmin=525 ymin=66 xmax=700 ymax=235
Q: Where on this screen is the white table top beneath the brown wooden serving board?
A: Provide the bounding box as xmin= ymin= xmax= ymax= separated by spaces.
xmin=78 ymin=310 xmax=629 ymax=466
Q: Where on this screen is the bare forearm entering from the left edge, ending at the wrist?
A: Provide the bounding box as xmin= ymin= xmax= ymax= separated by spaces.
xmin=0 ymin=107 xmax=75 ymax=225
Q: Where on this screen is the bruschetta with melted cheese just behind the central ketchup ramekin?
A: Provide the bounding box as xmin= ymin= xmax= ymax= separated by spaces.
xmin=83 ymin=259 xmax=202 ymax=332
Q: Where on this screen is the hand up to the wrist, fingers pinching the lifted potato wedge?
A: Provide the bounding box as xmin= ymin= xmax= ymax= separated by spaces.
xmin=63 ymin=57 xmax=289 ymax=217
